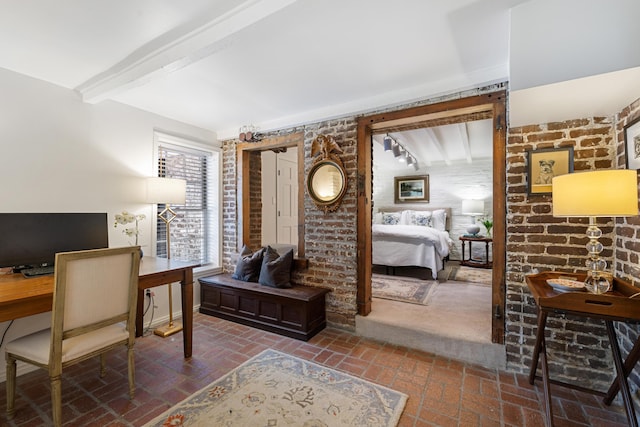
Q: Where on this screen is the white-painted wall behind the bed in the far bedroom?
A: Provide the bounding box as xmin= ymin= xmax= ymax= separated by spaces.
xmin=373 ymin=154 xmax=493 ymax=260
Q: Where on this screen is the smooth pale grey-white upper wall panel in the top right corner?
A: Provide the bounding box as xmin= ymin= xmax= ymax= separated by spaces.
xmin=509 ymin=0 xmax=640 ymax=90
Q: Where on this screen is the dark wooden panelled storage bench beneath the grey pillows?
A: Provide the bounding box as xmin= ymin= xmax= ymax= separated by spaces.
xmin=198 ymin=274 xmax=329 ymax=341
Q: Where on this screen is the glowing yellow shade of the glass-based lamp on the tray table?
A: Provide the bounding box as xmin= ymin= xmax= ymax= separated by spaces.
xmin=551 ymin=169 xmax=638 ymax=217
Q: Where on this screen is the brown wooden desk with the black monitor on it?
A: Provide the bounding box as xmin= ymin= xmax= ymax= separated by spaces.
xmin=0 ymin=256 xmax=200 ymax=358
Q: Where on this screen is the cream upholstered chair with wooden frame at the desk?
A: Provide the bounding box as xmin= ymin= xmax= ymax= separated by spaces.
xmin=6 ymin=246 xmax=140 ymax=426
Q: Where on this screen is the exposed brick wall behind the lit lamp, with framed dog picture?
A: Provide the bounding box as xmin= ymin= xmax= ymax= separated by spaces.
xmin=505 ymin=117 xmax=632 ymax=389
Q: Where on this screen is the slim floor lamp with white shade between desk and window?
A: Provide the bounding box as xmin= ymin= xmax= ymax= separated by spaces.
xmin=147 ymin=177 xmax=187 ymax=337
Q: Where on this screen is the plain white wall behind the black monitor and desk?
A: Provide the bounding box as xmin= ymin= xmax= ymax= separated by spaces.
xmin=0 ymin=69 xmax=218 ymax=381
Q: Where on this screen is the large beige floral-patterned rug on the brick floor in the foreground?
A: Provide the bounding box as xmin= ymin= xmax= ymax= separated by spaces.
xmin=145 ymin=349 xmax=407 ymax=427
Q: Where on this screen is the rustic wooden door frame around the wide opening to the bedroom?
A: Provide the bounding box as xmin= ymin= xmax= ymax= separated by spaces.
xmin=356 ymin=90 xmax=507 ymax=344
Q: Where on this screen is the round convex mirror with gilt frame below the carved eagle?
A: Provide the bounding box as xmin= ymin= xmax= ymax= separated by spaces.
xmin=307 ymin=159 xmax=347 ymax=211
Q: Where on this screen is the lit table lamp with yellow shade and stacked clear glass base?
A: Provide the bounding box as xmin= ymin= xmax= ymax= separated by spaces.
xmin=551 ymin=169 xmax=638 ymax=294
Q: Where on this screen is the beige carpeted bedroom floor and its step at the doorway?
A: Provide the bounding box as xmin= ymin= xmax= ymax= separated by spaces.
xmin=356 ymin=261 xmax=506 ymax=368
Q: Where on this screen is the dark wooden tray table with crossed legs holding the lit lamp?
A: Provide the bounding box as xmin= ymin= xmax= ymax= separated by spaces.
xmin=526 ymin=272 xmax=640 ymax=427
